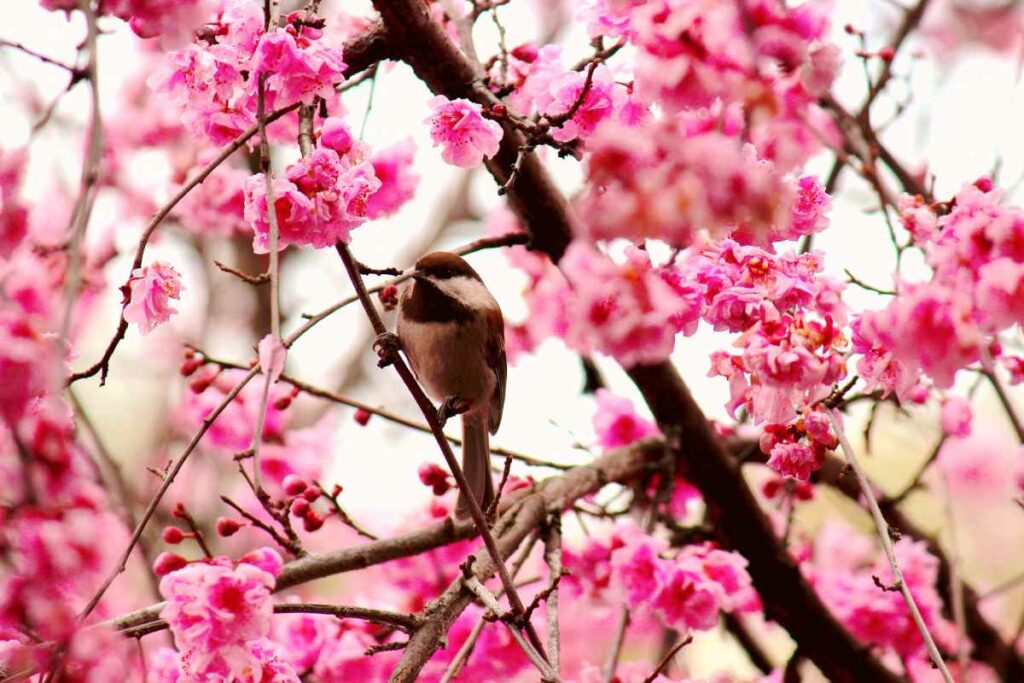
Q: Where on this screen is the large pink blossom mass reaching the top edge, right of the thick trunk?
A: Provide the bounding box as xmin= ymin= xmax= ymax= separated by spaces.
xmin=569 ymin=0 xmax=839 ymax=246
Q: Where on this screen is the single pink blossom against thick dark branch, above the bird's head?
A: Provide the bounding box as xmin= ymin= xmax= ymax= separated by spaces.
xmin=427 ymin=95 xmax=502 ymax=168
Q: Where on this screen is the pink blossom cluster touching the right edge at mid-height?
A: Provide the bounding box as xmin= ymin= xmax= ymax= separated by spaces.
xmin=853 ymin=178 xmax=1024 ymax=400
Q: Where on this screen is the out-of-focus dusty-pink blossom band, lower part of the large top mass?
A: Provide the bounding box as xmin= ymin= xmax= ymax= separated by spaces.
xmin=581 ymin=115 xmax=828 ymax=246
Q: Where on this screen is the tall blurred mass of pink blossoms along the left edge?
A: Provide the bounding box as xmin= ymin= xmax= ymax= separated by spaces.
xmin=0 ymin=161 xmax=136 ymax=680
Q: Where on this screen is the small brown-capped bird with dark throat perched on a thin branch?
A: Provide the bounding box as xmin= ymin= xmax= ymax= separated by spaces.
xmin=397 ymin=252 xmax=507 ymax=517
